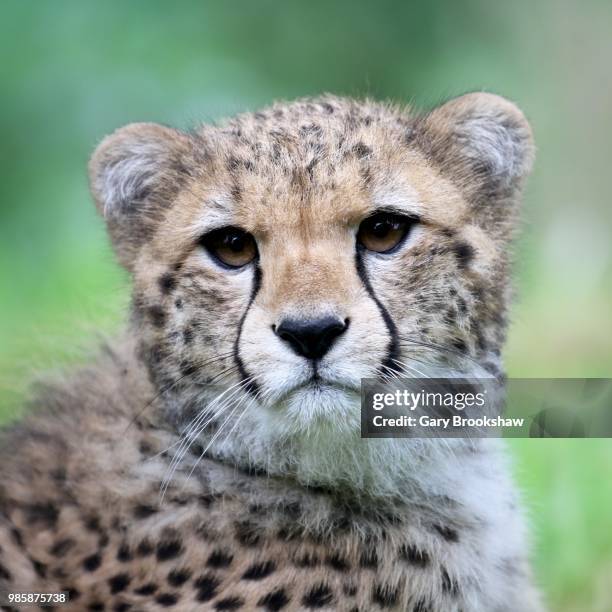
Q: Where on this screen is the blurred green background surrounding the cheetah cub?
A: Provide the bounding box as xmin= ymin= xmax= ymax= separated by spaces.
xmin=0 ymin=0 xmax=612 ymax=612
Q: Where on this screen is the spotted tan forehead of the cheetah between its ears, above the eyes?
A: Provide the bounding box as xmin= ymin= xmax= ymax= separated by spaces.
xmin=172 ymin=96 xmax=465 ymax=237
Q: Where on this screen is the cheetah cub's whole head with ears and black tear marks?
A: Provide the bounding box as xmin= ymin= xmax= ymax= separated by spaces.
xmin=90 ymin=94 xmax=532 ymax=450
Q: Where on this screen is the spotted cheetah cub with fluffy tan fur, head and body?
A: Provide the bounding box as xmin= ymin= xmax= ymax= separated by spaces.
xmin=0 ymin=93 xmax=541 ymax=612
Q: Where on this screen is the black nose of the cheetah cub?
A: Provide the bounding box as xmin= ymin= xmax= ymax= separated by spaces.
xmin=274 ymin=317 xmax=349 ymax=359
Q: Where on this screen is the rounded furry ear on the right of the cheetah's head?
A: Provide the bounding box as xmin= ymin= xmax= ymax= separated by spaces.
xmin=413 ymin=93 xmax=534 ymax=205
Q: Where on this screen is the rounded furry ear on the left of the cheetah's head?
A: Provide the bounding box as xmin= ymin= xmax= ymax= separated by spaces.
xmin=89 ymin=123 xmax=189 ymax=269
